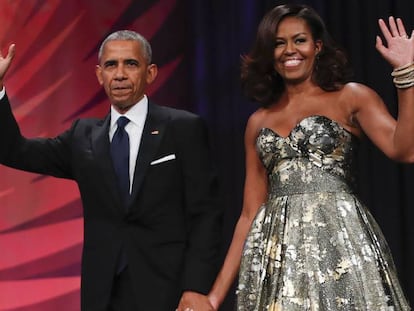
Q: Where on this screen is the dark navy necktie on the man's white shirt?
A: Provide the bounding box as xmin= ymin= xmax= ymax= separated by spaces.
xmin=111 ymin=116 xmax=129 ymax=207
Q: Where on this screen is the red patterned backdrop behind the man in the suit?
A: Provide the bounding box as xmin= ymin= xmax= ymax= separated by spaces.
xmin=0 ymin=0 xmax=191 ymax=311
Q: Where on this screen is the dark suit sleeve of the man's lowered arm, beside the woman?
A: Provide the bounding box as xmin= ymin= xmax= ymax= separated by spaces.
xmin=173 ymin=117 xmax=222 ymax=294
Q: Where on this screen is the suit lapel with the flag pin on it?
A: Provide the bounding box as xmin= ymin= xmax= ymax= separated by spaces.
xmin=130 ymin=103 xmax=168 ymax=208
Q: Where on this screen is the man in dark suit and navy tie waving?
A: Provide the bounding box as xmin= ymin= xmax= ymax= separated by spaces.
xmin=0 ymin=30 xmax=221 ymax=311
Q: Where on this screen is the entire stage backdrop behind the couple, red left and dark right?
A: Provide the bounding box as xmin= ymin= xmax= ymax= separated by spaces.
xmin=0 ymin=0 xmax=414 ymax=311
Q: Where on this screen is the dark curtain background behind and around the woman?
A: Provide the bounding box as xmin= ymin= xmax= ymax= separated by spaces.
xmin=185 ymin=0 xmax=414 ymax=310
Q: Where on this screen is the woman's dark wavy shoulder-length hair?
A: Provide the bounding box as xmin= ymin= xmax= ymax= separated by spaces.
xmin=241 ymin=4 xmax=351 ymax=107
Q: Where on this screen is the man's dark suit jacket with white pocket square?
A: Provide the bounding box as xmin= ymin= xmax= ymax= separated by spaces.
xmin=0 ymin=96 xmax=221 ymax=311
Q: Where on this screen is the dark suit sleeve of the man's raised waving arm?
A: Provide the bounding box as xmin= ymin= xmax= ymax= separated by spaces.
xmin=0 ymin=95 xmax=72 ymax=179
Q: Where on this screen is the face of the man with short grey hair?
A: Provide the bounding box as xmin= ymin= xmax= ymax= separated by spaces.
xmin=96 ymin=40 xmax=157 ymax=113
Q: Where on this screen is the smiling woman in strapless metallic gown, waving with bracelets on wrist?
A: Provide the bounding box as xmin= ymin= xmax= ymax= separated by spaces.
xmin=208 ymin=5 xmax=414 ymax=311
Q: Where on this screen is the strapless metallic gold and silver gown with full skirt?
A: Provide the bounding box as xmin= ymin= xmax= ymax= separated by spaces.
xmin=237 ymin=116 xmax=410 ymax=311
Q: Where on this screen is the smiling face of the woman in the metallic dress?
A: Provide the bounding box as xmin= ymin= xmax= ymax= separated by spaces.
xmin=274 ymin=17 xmax=322 ymax=84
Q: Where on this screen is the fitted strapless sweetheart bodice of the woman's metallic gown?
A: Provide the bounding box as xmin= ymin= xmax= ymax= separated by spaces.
xmin=256 ymin=115 xmax=358 ymax=195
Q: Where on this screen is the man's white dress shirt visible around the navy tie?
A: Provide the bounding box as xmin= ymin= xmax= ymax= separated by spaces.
xmin=109 ymin=95 xmax=148 ymax=193
